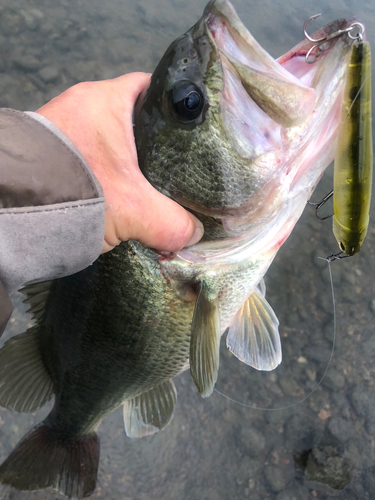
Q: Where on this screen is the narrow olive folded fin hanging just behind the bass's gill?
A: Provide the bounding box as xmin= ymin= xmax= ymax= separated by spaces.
xmin=190 ymin=281 xmax=220 ymax=398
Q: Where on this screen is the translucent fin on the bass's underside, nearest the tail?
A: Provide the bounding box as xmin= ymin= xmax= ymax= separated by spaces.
xmin=123 ymin=380 xmax=177 ymax=438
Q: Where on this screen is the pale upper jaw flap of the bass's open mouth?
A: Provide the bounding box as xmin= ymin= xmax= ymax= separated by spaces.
xmin=206 ymin=2 xmax=316 ymax=127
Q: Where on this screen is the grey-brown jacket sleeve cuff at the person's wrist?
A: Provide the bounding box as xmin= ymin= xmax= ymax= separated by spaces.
xmin=0 ymin=109 xmax=105 ymax=334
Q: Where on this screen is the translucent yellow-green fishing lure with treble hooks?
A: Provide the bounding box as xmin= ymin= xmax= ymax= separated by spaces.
xmin=304 ymin=16 xmax=373 ymax=258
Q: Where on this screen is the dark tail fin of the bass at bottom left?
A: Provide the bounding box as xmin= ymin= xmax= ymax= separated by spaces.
xmin=0 ymin=422 xmax=100 ymax=498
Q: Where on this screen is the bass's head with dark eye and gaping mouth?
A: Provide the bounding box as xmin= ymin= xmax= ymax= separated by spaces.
xmin=134 ymin=0 xmax=362 ymax=245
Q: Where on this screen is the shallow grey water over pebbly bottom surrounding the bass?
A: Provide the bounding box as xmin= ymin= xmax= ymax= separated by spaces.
xmin=0 ymin=0 xmax=375 ymax=500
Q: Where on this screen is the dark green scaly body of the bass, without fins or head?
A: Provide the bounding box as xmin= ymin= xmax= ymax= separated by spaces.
xmin=43 ymin=243 xmax=194 ymax=438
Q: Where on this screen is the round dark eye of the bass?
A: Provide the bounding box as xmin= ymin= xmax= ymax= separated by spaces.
xmin=172 ymin=81 xmax=205 ymax=121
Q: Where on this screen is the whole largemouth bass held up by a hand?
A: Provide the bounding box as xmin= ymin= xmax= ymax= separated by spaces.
xmin=0 ymin=0 xmax=362 ymax=498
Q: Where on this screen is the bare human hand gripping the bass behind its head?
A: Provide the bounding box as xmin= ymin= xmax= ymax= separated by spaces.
xmin=36 ymin=73 xmax=203 ymax=253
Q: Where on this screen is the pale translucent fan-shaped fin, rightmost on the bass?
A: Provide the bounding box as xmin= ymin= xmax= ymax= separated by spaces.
xmin=227 ymin=287 xmax=282 ymax=371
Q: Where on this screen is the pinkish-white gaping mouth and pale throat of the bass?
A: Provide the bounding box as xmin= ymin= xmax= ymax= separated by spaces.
xmin=172 ymin=0 xmax=357 ymax=254
